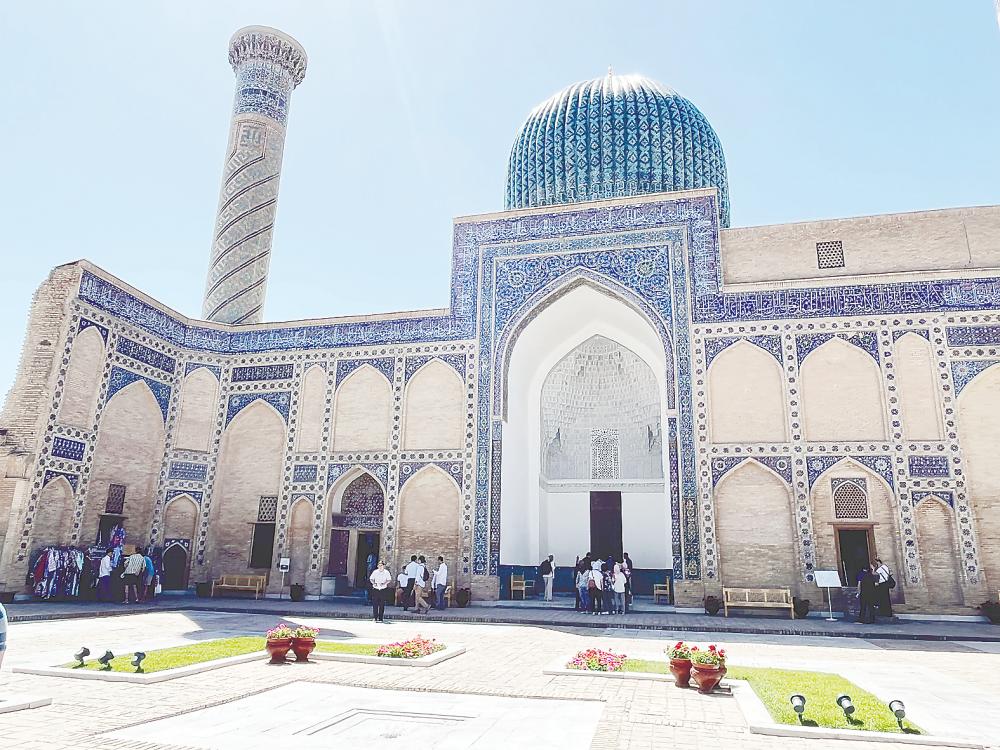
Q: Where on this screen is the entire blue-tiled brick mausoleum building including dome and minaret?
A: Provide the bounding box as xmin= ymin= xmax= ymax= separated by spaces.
xmin=0 ymin=27 xmax=1000 ymax=612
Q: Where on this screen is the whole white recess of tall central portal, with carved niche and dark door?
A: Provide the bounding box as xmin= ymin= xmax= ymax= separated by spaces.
xmin=500 ymin=283 xmax=672 ymax=585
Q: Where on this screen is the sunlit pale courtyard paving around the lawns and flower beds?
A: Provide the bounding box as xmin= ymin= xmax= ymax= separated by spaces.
xmin=0 ymin=600 xmax=1000 ymax=750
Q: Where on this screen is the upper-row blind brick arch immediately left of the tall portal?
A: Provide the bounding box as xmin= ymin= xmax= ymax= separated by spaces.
xmin=403 ymin=359 xmax=466 ymax=450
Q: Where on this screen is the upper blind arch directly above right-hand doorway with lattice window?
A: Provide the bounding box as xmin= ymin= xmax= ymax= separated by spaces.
xmin=800 ymin=336 xmax=886 ymax=442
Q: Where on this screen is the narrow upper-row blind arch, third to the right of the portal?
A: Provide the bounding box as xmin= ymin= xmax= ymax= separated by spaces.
xmin=895 ymin=331 xmax=944 ymax=440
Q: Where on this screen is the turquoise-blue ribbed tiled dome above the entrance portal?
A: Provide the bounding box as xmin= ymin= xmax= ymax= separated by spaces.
xmin=507 ymin=73 xmax=729 ymax=226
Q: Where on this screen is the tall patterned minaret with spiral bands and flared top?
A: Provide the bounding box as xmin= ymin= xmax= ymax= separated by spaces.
xmin=202 ymin=26 xmax=307 ymax=323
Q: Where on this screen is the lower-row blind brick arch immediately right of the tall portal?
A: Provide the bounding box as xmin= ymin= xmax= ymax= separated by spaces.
xmin=714 ymin=459 xmax=801 ymax=590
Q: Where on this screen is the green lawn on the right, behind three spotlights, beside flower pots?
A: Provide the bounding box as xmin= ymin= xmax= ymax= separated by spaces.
xmin=622 ymin=659 xmax=922 ymax=734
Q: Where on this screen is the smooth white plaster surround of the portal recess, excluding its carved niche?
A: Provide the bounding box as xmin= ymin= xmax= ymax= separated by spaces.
xmin=500 ymin=282 xmax=674 ymax=568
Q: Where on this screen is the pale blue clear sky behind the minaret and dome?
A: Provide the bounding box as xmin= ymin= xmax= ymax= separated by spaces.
xmin=0 ymin=0 xmax=1000 ymax=397
